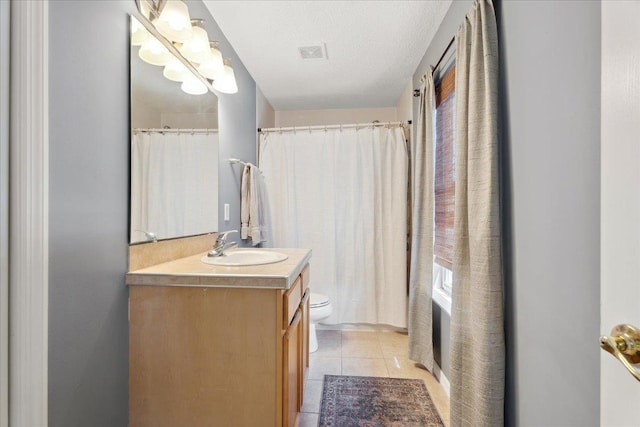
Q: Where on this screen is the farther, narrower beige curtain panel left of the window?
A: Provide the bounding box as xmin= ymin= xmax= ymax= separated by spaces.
xmin=408 ymin=69 xmax=435 ymax=372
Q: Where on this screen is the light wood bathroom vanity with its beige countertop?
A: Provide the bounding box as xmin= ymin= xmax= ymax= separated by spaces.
xmin=126 ymin=249 xmax=311 ymax=427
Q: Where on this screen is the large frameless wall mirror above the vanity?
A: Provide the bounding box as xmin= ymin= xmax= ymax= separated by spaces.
xmin=129 ymin=16 xmax=219 ymax=243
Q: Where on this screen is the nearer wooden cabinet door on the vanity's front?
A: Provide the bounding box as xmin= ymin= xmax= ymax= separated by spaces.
xmin=282 ymin=309 xmax=302 ymax=427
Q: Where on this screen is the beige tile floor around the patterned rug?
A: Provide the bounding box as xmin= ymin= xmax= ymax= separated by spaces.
xmin=300 ymin=330 xmax=449 ymax=427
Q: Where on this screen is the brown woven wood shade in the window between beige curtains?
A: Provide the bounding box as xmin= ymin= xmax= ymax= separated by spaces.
xmin=433 ymin=66 xmax=456 ymax=270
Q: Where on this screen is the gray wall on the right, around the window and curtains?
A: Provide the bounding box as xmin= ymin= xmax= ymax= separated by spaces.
xmin=414 ymin=0 xmax=600 ymax=426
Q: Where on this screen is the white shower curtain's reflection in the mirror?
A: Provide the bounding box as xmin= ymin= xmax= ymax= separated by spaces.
xmin=130 ymin=132 xmax=218 ymax=242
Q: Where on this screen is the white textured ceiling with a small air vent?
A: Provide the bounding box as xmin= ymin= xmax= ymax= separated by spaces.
xmin=204 ymin=0 xmax=451 ymax=110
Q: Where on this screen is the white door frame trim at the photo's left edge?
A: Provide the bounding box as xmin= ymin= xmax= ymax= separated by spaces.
xmin=8 ymin=0 xmax=49 ymax=426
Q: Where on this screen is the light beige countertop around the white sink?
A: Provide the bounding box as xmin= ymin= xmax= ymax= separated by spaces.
xmin=126 ymin=248 xmax=311 ymax=289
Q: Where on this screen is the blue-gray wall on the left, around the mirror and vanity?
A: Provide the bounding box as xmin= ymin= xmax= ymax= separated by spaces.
xmin=49 ymin=0 xmax=255 ymax=427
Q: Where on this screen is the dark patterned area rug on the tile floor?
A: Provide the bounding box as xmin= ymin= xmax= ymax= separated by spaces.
xmin=318 ymin=375 xmax=444 ymax=427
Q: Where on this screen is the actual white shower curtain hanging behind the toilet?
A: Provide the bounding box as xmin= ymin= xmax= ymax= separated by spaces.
xmin=260 ymin=127 xmax=408 ymax=327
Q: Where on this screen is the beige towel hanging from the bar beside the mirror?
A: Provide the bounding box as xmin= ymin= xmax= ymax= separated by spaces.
xmin=240 ymin=163 xmax=269 ymax=246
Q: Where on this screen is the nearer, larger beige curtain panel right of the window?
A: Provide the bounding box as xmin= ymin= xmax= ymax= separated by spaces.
xmin=451 ymin=0 xmax=505 ymax=426
